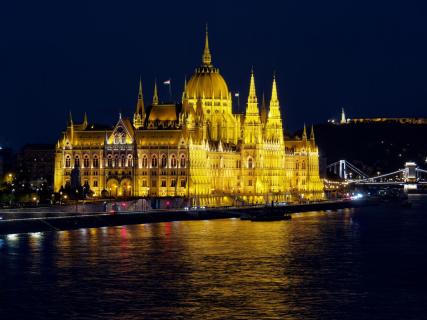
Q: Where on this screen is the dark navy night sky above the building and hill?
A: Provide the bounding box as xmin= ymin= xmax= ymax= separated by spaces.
xmin=0 ymin=0 xmax=427 ymax=148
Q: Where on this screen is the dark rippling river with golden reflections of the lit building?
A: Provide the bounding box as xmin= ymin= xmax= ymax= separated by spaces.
xmin=0 ymin=196 xmax=427 ymax=320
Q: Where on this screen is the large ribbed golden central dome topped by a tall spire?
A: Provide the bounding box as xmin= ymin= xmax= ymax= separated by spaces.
xmin=185 ymin=30 xmax=228 ymax=99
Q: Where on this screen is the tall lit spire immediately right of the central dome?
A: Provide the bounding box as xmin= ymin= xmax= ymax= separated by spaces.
xmin=243 ymin=69 xmax=262 ymax=144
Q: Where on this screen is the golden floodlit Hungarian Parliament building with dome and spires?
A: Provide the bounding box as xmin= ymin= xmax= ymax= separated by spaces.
xmin=54 ymin=32 xmax=324 ymax=206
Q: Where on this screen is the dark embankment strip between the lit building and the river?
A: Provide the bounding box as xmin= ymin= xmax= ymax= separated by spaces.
xmin=0 ymin=200 xmax=378 ymax=234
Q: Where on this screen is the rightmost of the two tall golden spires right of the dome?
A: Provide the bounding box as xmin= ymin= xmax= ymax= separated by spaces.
xmin=265 ymin=75 xmax=283 ymax=144
